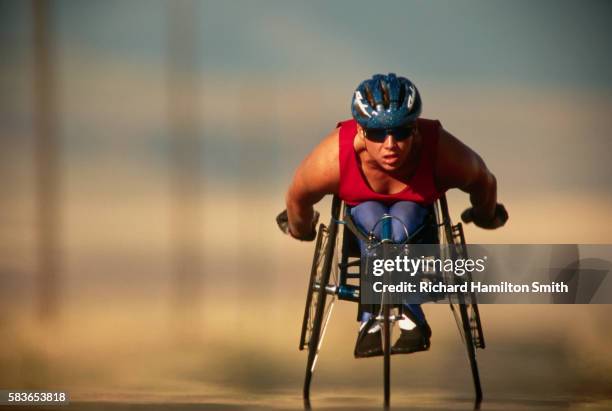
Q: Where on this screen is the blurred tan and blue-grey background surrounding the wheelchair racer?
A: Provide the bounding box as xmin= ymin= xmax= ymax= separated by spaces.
xmin=0 ymin=0 xmax=612 ymax=409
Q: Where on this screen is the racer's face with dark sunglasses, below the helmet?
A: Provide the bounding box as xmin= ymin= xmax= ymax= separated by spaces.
xmin=363 ymin=127 xmax=415 ymax=172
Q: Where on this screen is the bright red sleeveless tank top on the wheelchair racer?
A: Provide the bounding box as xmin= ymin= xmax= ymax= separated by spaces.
xmin=338 ymin=119 xmax=443 ymax=206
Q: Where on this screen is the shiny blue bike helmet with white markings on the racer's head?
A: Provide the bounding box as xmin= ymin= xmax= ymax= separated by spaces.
xmin=351 ymin=73 xmax=421 ymax=129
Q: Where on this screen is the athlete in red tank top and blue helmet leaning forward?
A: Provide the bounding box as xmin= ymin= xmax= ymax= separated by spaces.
xmin=277 ymin=73 xmax=508 ymax=357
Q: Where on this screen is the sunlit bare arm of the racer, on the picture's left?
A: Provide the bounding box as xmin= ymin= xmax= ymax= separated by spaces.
xmin=285 ymin=129 xmax=340 ymax=238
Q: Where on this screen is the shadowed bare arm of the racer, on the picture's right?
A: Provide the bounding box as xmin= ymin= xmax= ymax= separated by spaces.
xmin=436 ymin=129 xmax=497 ymax=221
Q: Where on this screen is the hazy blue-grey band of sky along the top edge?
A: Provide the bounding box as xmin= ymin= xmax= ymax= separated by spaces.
xmin=0 ymin=0 xmax=612 ymax=86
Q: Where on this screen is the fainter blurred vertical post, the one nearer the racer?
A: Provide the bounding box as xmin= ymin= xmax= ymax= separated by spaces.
xmin=167 ymin=1 xmax=204 ymax=331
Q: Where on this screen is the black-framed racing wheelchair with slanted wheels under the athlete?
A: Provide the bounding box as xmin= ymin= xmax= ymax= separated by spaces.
xmin=299 ymin=196 xmax=485 ymax=406
